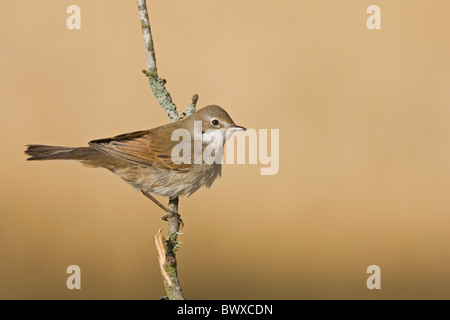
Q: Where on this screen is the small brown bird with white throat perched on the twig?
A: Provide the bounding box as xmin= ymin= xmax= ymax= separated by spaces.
xmin=25 ymin=105 xmax=245 ymax=219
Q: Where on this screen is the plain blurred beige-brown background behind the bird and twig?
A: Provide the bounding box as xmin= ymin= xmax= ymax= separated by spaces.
xmin=0 ymin=0 xmax=450 ymax=299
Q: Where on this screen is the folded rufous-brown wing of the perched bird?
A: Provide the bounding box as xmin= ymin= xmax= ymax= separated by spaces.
xmin=89 ymin=130 xmax=192 ymax=172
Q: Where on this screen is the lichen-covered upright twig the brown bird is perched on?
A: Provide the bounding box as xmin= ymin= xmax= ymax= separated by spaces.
xmin=137 ymin=0 xmax=192 ymax=300
